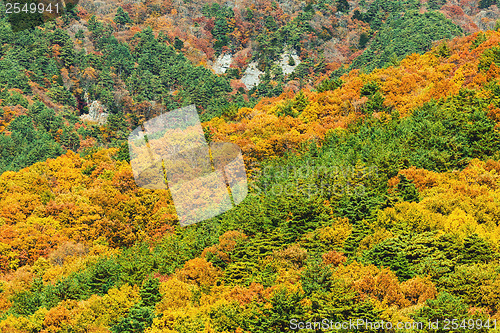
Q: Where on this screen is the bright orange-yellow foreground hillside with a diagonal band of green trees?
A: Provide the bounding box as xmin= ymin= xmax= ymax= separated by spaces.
xmin=0 ymin=28 xmax=500 ymax=333
